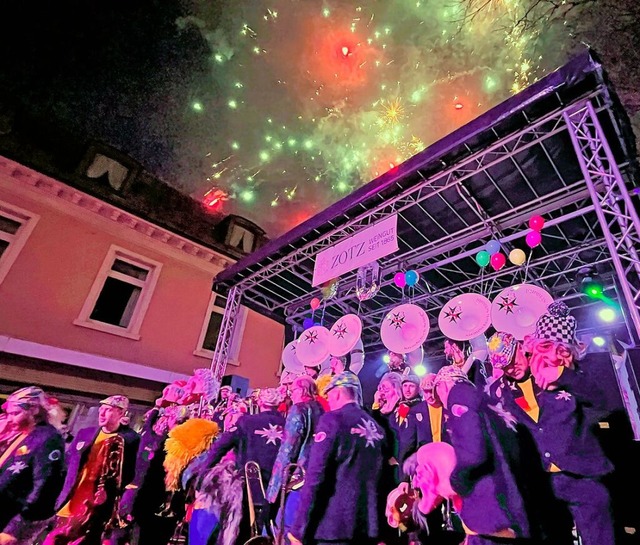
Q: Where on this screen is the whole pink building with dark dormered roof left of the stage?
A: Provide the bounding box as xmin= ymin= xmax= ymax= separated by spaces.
xmin=0 ymin=123 xmax=284 ymax=417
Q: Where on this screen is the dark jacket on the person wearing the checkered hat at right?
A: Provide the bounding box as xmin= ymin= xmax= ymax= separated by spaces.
xmin=489 ymin=368 xmax=613 ymax=477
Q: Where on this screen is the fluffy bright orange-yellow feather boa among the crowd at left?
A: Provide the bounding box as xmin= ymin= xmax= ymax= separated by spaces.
xmin=164 ymin=418 xmax=220 ymax=492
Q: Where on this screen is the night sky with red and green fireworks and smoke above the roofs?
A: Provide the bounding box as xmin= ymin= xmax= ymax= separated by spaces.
xmin=0 ymin=0 xmax=640 ymax=237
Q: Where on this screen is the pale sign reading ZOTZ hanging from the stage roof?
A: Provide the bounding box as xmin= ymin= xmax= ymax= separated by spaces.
xmin=311 ymin=214 xmax=398 ymax=288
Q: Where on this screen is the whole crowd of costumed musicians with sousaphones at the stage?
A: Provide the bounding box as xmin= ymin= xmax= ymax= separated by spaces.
xmin=0 ymin=264 xmax=616 ymax=545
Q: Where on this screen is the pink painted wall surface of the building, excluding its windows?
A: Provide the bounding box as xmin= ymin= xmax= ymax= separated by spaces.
xmin=0 ymin=176 xmax=284 ymax=387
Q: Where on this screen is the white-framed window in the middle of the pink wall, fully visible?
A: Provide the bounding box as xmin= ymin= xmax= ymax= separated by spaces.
xmin=74 ymin=246 xmax=161 ymax=339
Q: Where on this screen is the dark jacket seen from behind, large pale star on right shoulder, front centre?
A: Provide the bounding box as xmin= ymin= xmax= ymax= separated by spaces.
xmin=291 ymin=403 xmax=386 ymax=543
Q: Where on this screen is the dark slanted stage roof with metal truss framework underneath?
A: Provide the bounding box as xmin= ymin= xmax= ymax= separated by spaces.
xmin=213 ymin=51 xmax=635 ymax=353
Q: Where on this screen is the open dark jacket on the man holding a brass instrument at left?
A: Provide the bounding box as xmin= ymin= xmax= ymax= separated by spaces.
xmin=56 ymin=426 xmax=140 ymax=510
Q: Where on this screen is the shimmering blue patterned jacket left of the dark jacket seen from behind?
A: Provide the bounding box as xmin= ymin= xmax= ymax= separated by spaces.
xmin=267 ymin=399 xmax=324 ymax=503
